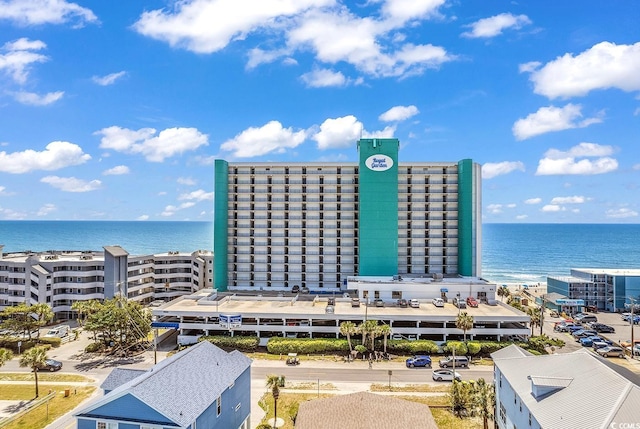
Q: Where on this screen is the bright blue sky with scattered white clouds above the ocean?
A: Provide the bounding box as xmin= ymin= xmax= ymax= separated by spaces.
xmin=0 ymin=0 xmax=640 ymax=223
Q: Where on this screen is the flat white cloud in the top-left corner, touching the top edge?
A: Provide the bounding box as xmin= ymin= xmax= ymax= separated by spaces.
xmin=0 ymin=0 xmax=98 ymax=27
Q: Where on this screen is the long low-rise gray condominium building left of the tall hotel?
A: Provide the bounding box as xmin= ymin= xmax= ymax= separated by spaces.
xmin=0 ymin=246 xmax=213 ymax=319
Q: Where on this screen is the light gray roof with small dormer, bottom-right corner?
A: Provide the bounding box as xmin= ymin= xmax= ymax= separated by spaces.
xmin=495 ymin=350 xmax=640 ymax=429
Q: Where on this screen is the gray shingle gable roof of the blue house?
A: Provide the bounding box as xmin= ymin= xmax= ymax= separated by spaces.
xmin=77 ymin=341 xmax=251 ymax=427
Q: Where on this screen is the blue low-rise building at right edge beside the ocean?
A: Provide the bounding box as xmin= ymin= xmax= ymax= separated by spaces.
xmin=547 ymin=268 xmax=640 ymax=311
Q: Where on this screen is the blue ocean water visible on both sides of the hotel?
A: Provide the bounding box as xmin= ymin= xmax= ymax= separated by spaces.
xmin=0 ymin=221 xmax=640 ymax=284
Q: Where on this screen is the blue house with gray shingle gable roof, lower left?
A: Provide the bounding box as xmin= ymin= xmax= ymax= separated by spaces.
xmin=75 ymin=341 xmax=251 ymax=429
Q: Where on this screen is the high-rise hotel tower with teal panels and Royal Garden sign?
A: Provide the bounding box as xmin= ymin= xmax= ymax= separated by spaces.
xmin=214 ymin=139 xmax=481 ymax=291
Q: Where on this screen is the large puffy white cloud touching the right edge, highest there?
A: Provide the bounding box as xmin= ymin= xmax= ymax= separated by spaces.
xmin=529 ymin=42 xmax=640 ymax=99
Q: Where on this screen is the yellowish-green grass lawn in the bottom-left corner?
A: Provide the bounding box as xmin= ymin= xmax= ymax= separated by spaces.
xmin=0 ymin=384 xmax=95 ymax=429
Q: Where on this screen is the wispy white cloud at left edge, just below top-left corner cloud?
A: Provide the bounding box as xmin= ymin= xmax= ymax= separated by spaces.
xmin=0 ymin=37 xmax=49 ymax=84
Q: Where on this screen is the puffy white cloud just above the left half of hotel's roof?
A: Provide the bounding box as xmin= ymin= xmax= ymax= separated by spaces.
xmin=220 ymin=121 xmax=306 ymax=158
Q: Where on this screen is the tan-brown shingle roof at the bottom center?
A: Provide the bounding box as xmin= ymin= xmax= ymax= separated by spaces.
xmin=296 ymin=392 xmax=438 ymax=429
